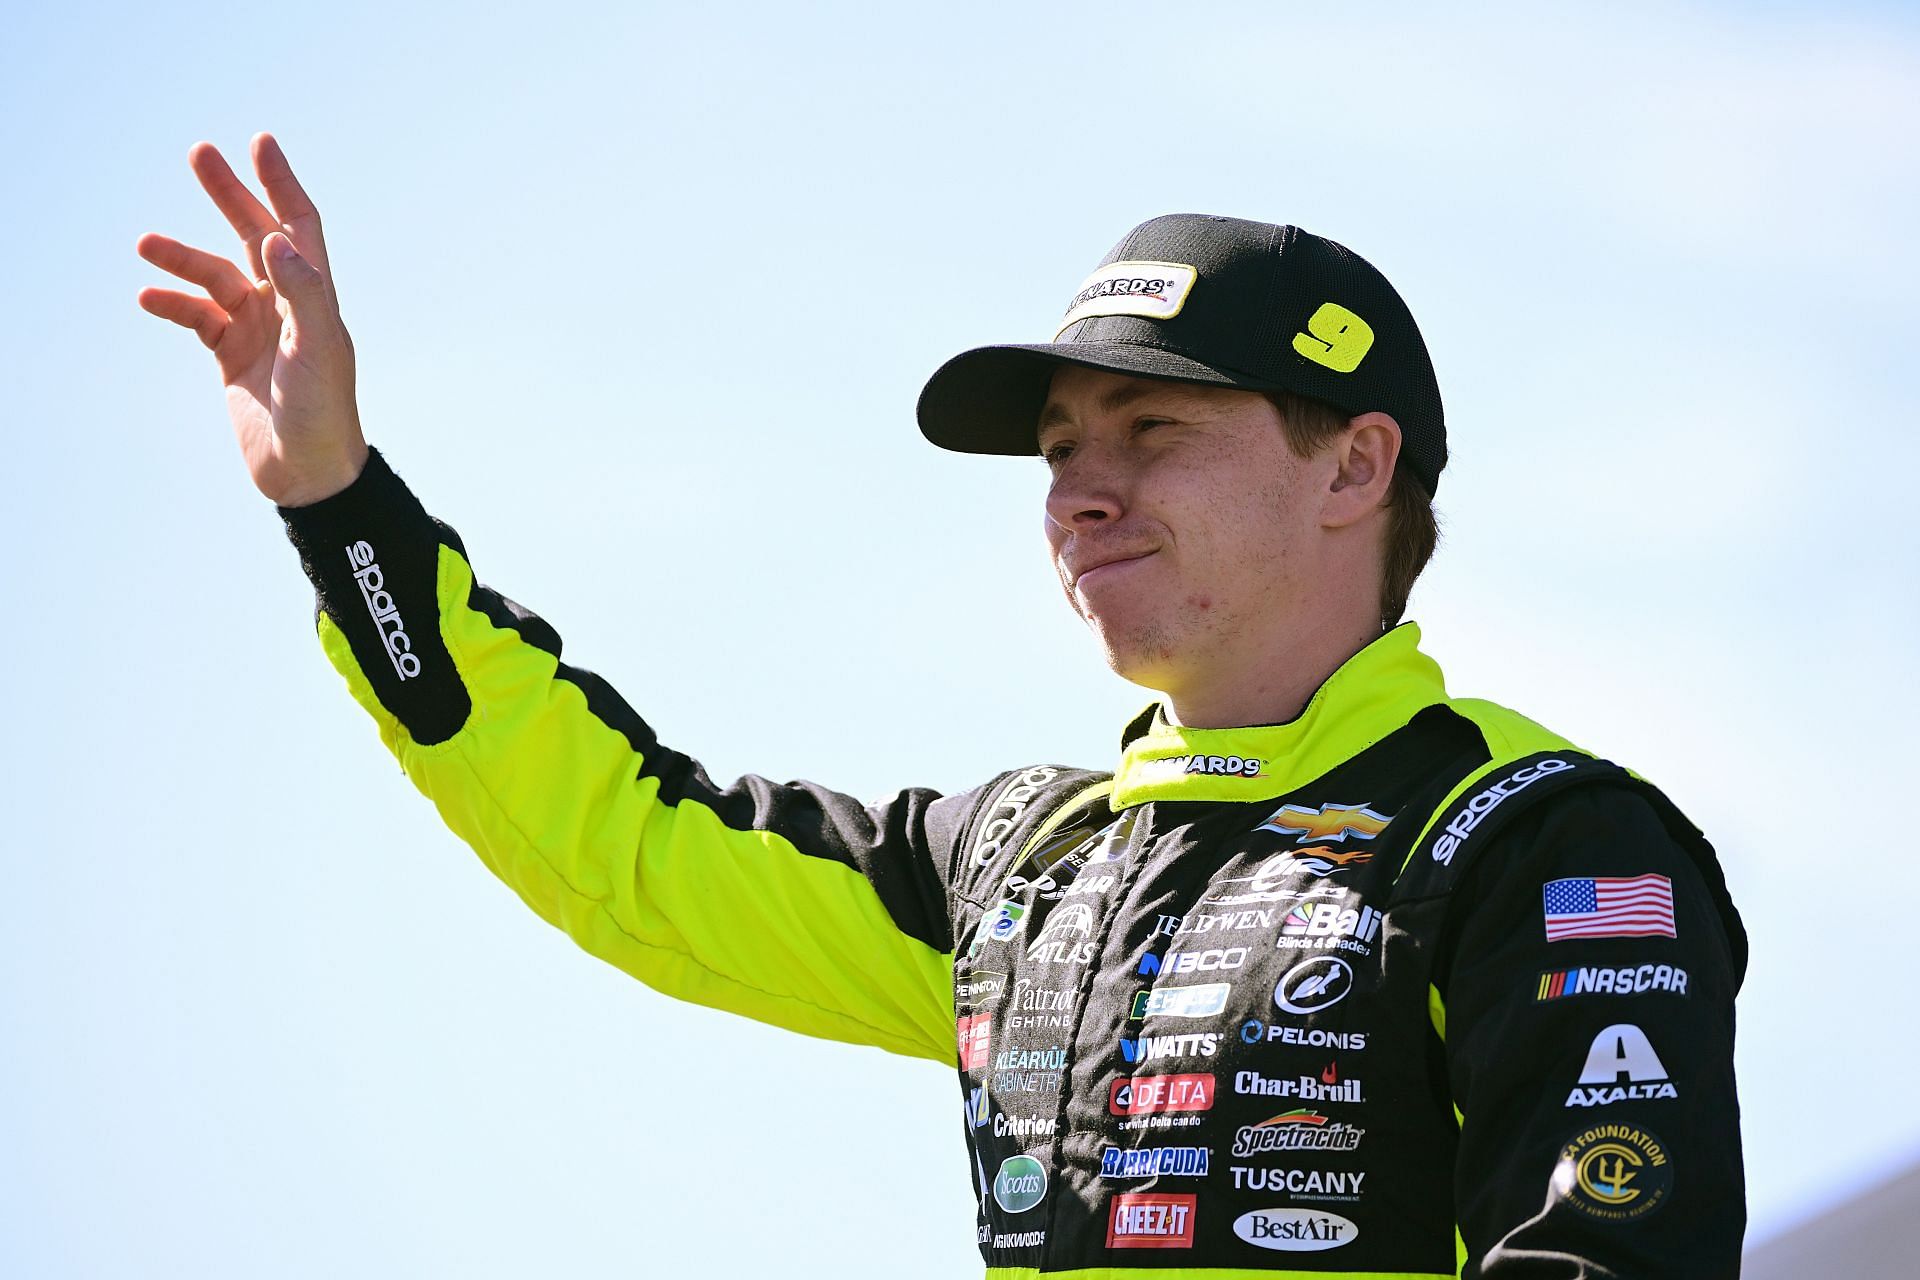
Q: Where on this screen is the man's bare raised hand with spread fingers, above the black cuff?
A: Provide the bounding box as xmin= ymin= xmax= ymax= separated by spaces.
xmin=136 ymin=134 xmax=367 ymax=507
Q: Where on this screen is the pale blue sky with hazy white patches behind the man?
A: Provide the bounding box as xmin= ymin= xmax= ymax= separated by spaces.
xmin=0 ymin=0 xmax=1920 ymax=1278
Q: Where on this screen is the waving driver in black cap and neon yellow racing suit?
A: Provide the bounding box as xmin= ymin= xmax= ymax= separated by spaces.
xmin=140 ymin=136 xmax=1745 ymax=1280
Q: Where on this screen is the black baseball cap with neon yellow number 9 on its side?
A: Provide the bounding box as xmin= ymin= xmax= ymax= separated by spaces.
xmin=920 ymin=213 xmax=1446 ymax=493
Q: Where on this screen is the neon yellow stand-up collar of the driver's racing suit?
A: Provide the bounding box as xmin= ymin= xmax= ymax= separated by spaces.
xmin=1110 ymin=622 xmax=1448 ymax=810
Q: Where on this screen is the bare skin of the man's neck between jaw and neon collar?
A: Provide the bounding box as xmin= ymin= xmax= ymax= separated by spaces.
xmin=1164 ymin=620 xmax=1380 ymax=729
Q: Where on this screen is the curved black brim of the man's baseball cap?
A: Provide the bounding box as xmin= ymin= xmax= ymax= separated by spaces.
xmin=918 ymin=342 xmax=1277 ymax=457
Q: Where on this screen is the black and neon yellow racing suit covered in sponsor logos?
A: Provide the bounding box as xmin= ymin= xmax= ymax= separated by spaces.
xmin=282 ymin=453 xmax=1745 ymax=1280
